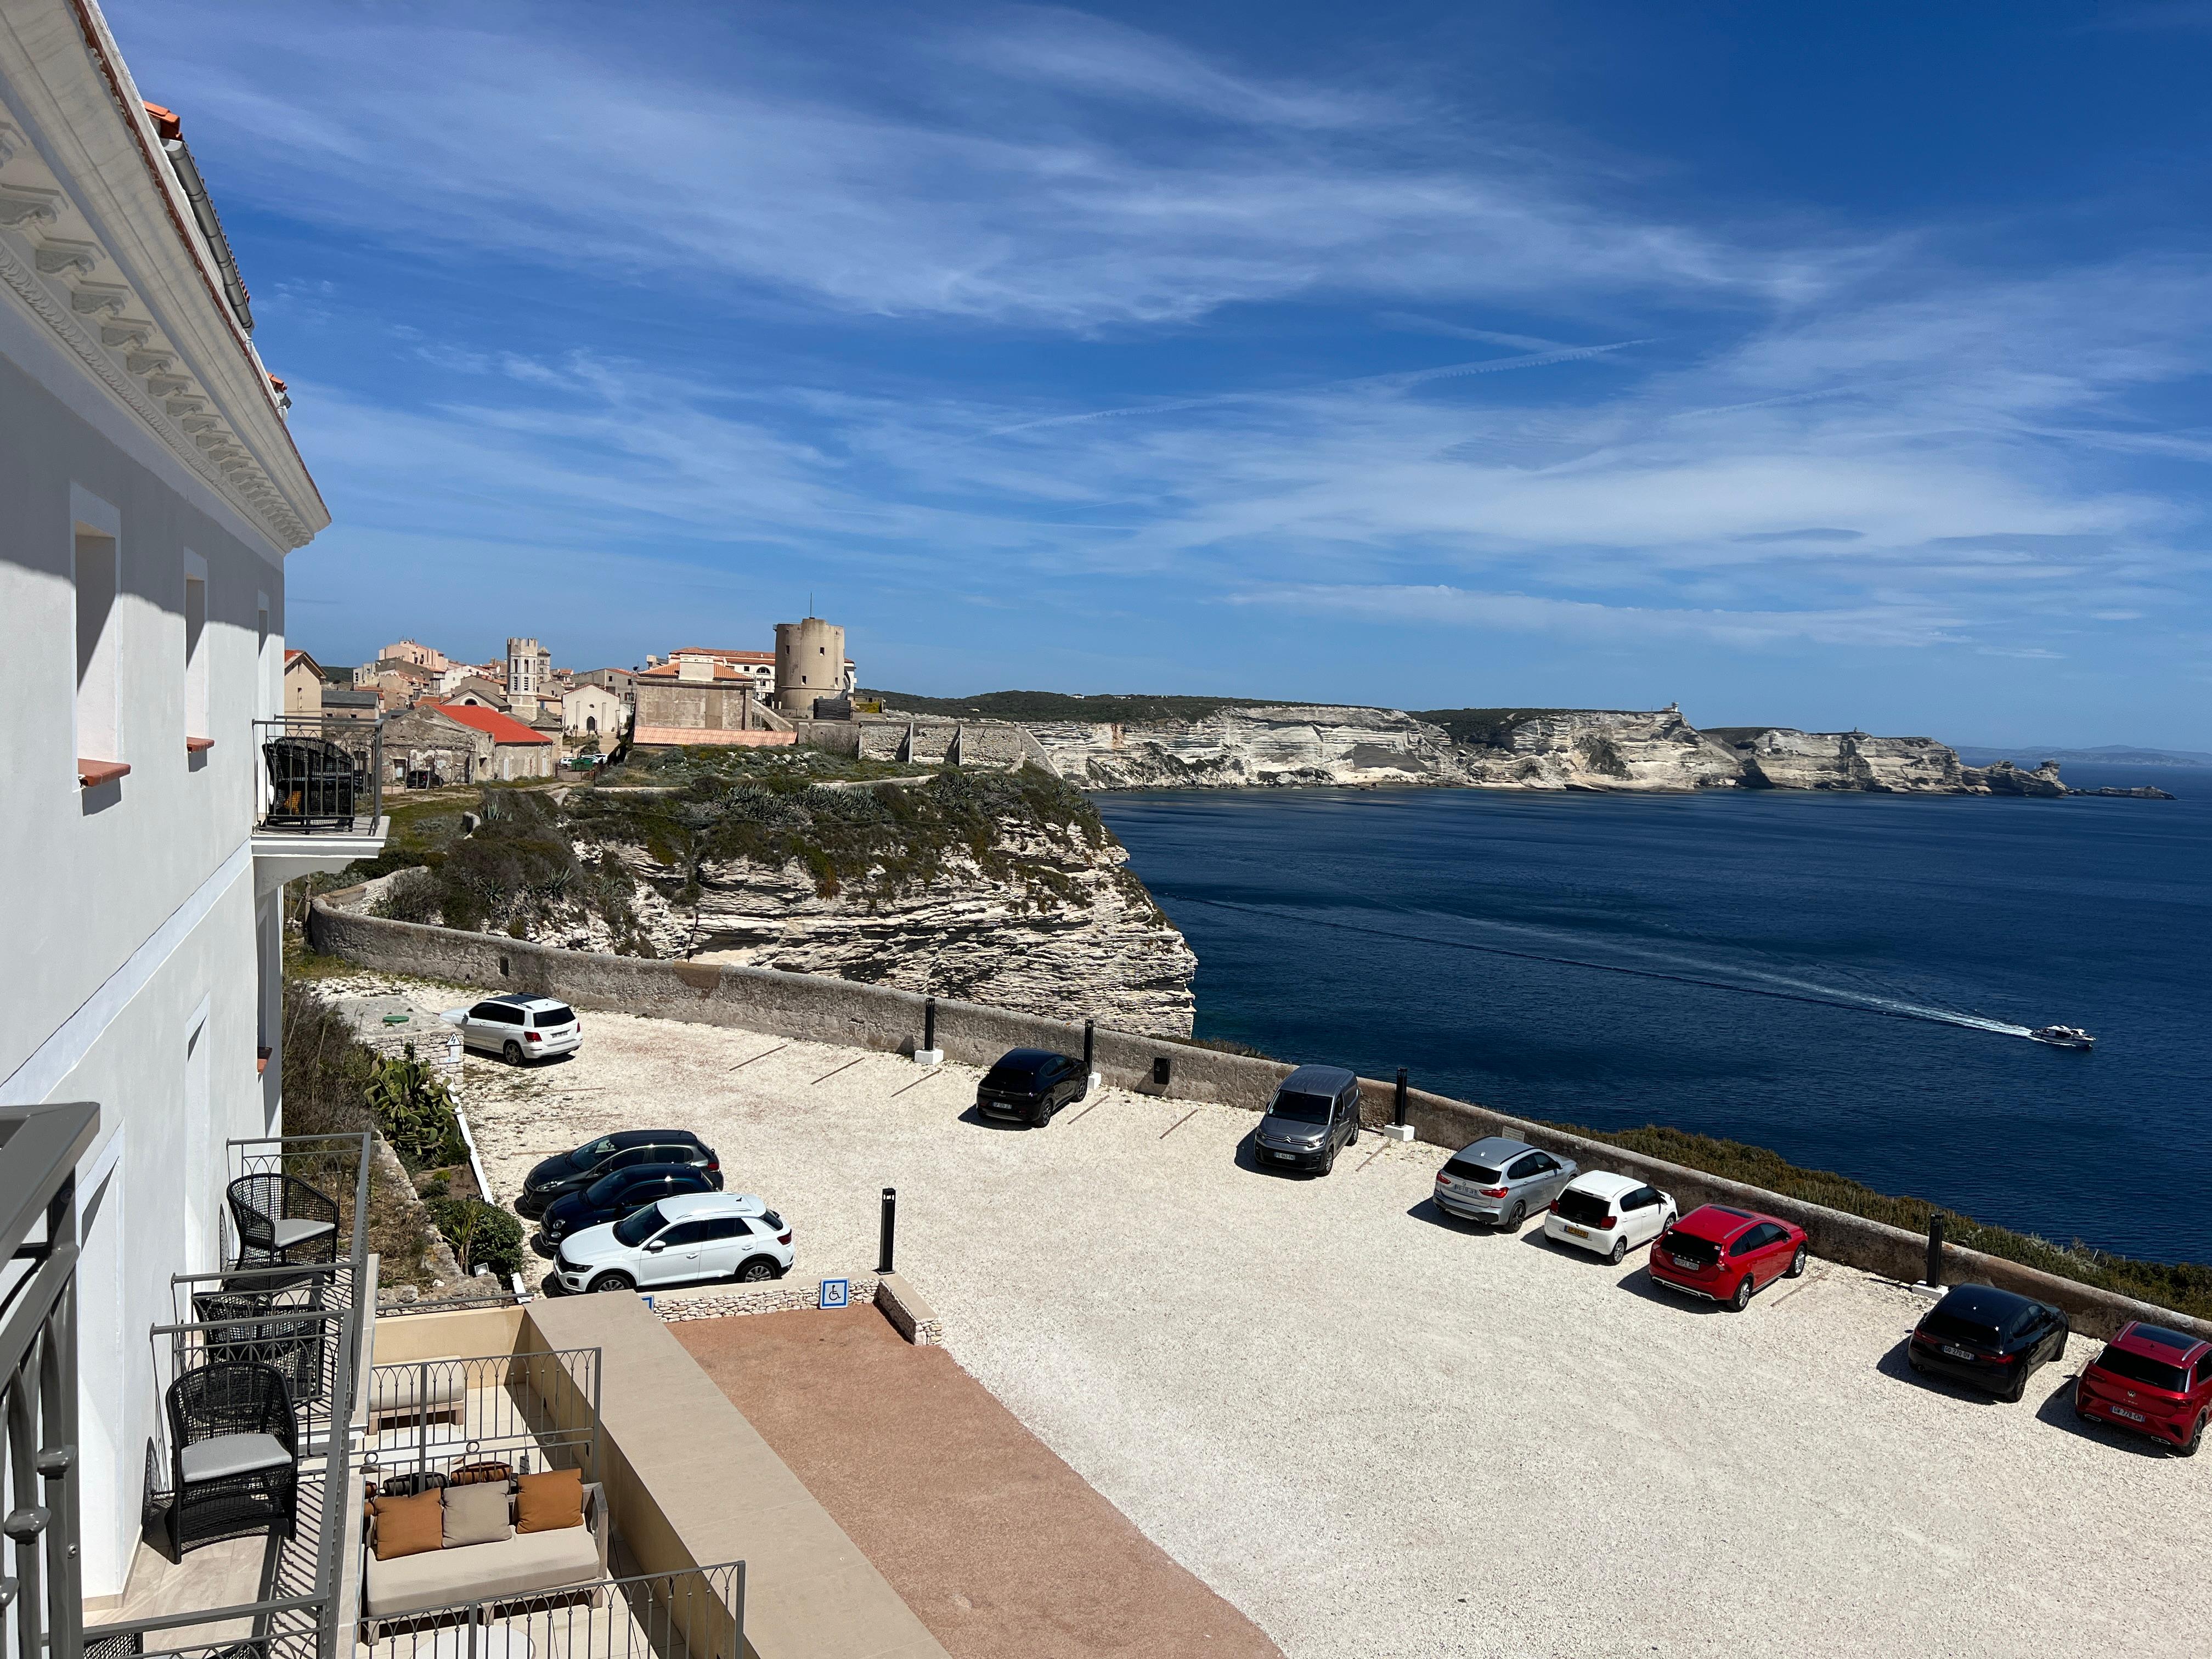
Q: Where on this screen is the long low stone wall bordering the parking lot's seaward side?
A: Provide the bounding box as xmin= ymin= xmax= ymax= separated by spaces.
xmin=307 ymin=889 xmax=2212 ymax=1338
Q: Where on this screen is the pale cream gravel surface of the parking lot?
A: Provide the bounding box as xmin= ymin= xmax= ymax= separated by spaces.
xmin=356 ymin=980 xmax=2212 ymax=1659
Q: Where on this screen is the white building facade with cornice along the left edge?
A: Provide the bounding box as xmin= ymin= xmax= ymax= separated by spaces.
xmin=0 ymin=0 xmax=363 ymax=1604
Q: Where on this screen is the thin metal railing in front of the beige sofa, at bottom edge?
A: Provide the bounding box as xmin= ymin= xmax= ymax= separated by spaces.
xmin=365 ymin=1562 xmax=746 ymax=1659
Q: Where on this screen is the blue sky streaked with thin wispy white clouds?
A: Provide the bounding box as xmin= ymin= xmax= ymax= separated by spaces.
xmin=109 ymin=0 xmax=2212 ymax=748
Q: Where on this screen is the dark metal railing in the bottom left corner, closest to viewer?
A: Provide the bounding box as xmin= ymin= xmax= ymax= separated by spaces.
xmin=0 ymin=1102 xmax=99 ymax=1659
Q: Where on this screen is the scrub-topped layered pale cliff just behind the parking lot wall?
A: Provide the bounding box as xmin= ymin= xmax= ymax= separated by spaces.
xmin=367 ymin=750 xmax=1197 ymax=1035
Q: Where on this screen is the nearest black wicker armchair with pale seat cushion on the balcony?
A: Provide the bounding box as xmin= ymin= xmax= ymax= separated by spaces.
xmin=168 ymin=1361 xmax=298 ymax=1560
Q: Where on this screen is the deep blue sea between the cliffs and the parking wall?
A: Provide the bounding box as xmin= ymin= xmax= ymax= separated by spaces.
xmin=1097 ymin=768 xmax=2212 ymax=1261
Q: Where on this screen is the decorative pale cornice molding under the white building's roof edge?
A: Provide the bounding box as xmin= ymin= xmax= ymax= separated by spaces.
xmin=0 ymin=89 xmax=314 ymax=551
